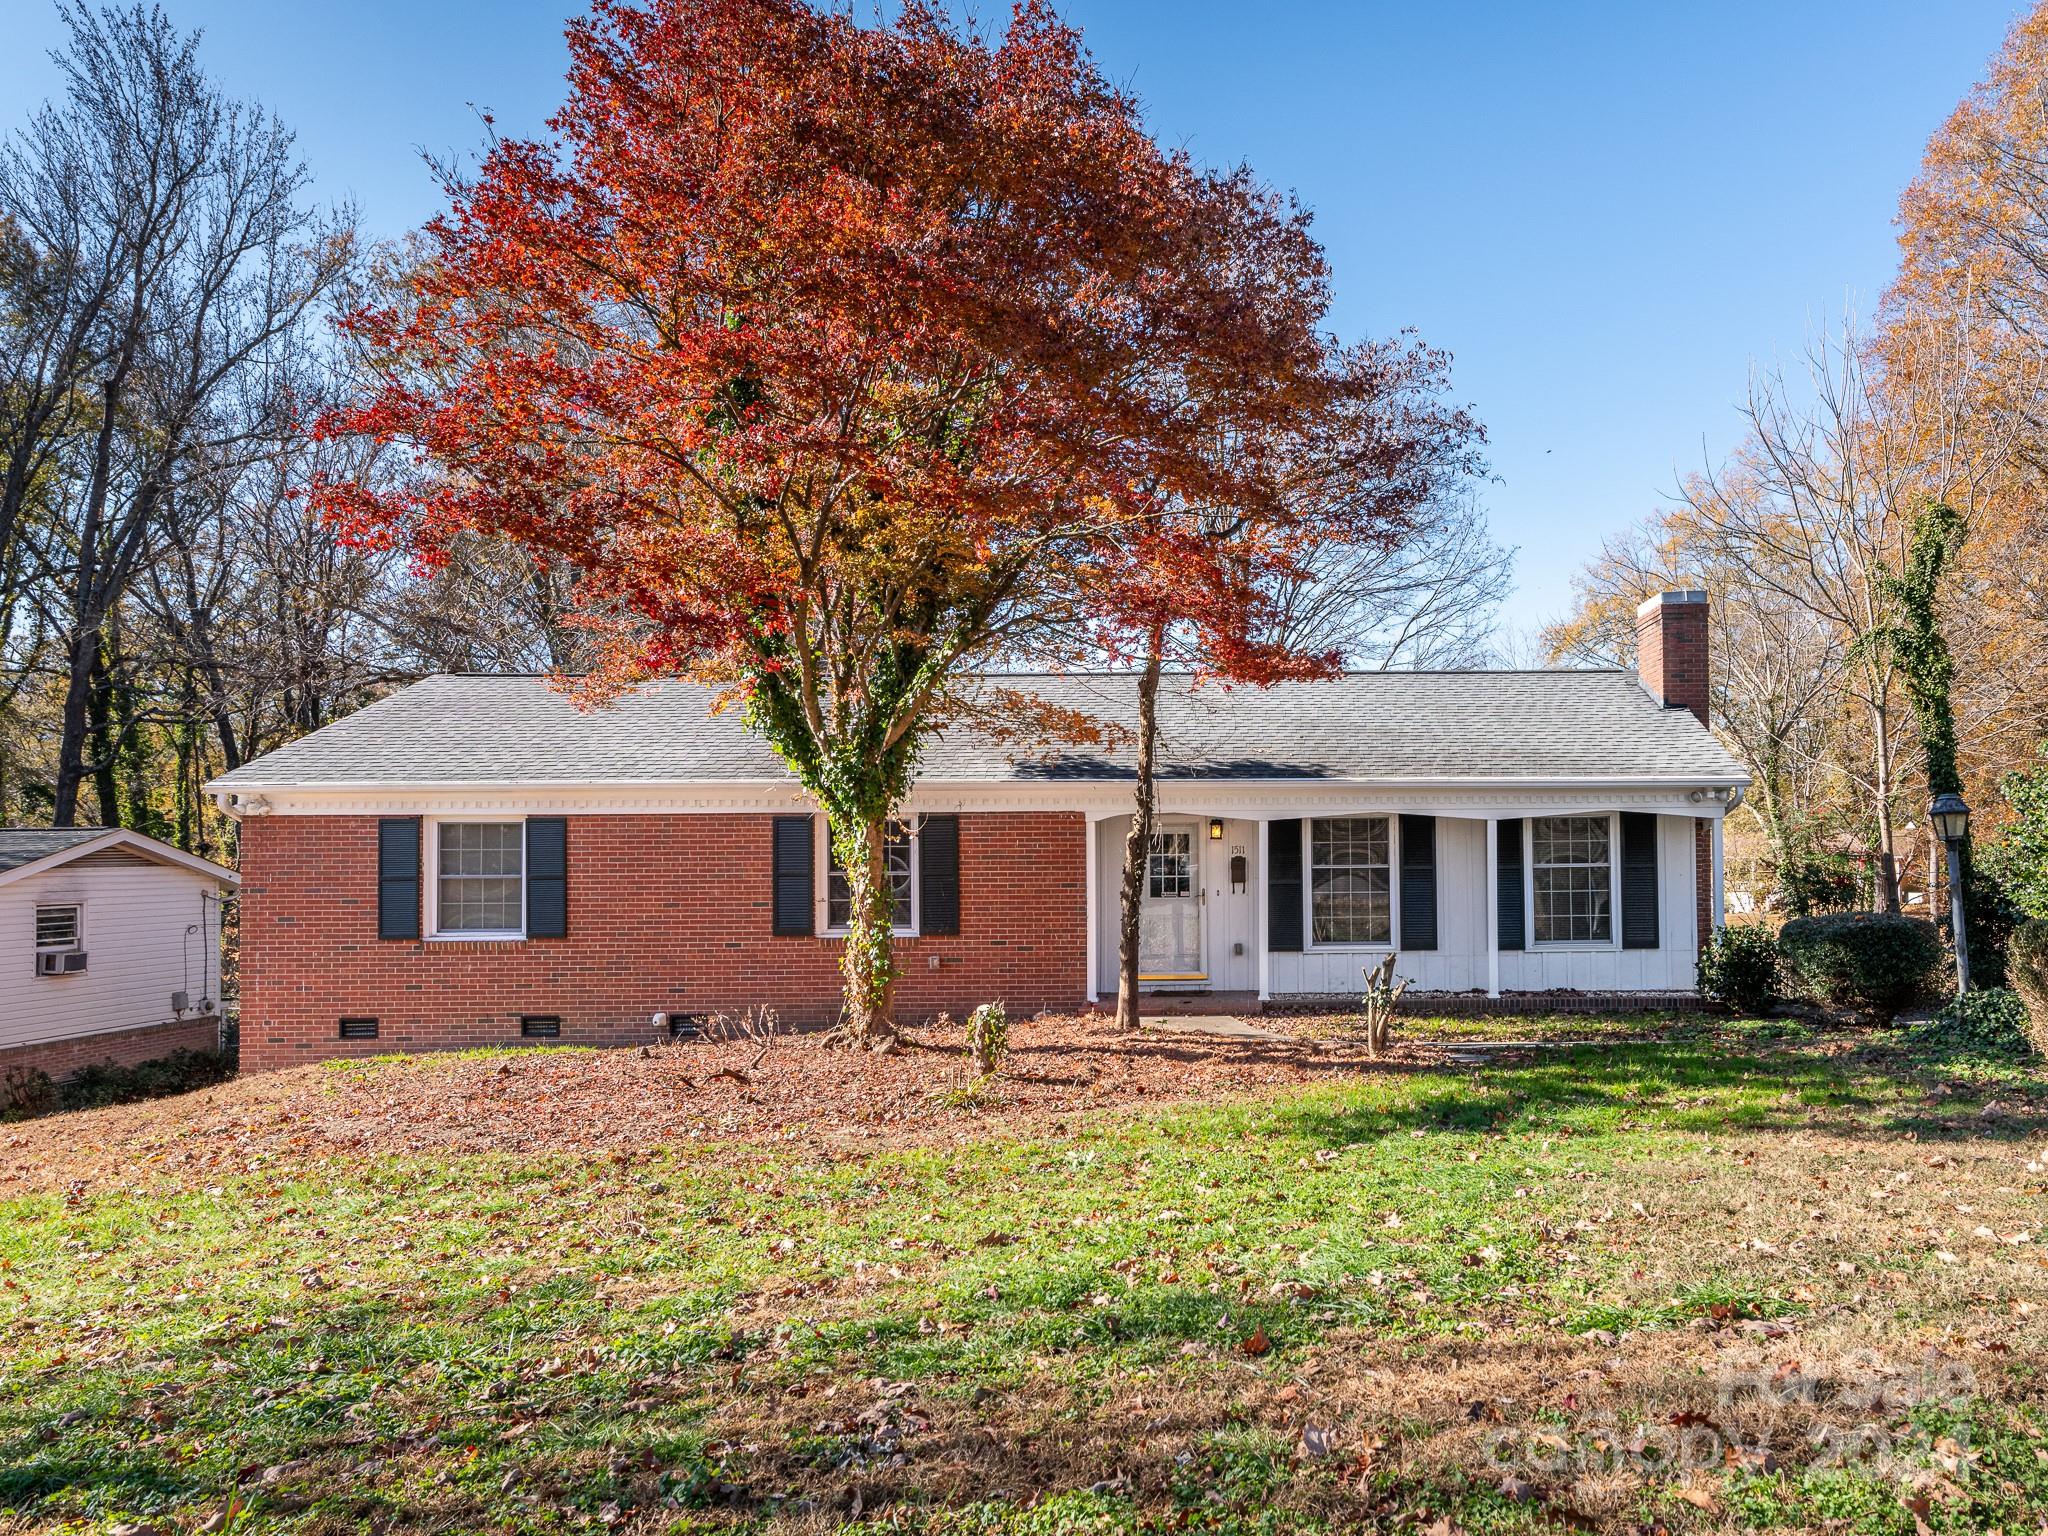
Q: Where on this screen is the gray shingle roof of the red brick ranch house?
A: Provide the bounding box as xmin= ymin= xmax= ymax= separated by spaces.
xmin=215 ymin=672 xmax=1745 ymax=791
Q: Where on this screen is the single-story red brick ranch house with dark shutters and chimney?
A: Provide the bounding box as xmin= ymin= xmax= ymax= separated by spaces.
xmin=211 ymin=592 xmax=1747 ymax=1069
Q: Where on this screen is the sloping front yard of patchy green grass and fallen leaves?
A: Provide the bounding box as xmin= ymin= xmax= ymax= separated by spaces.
xmin=0 ymin=1020 xmax=2048 ymax=1536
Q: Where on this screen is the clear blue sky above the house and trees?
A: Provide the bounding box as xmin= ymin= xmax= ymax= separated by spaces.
xmin=0 ymin=0 xmax=2017 ymax=629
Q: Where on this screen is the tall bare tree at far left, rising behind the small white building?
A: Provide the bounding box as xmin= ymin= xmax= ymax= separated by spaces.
xmin=6 ymin=0 xmax=354 ymax=825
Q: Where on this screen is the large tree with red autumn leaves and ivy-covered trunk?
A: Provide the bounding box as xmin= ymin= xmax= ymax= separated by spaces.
xmin=317 ymin=0 xmax=1470 ymax=1044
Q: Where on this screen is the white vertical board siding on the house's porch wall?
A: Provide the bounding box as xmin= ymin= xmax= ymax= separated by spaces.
xmin=1094 ymin=815 xmax=1700 ymax=997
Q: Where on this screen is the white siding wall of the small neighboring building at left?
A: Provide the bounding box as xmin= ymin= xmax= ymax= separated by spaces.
xmin=0 ymin=848 xmax=221 ymax=1051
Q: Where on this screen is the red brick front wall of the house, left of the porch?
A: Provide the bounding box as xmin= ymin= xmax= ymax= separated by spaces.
xmin=240 ymin=811 xmax=1087 ymax=1071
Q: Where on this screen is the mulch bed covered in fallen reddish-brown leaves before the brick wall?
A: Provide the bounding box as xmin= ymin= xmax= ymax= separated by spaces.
xmin=0 ymin=1014 xmax=1444 ymax=1196
